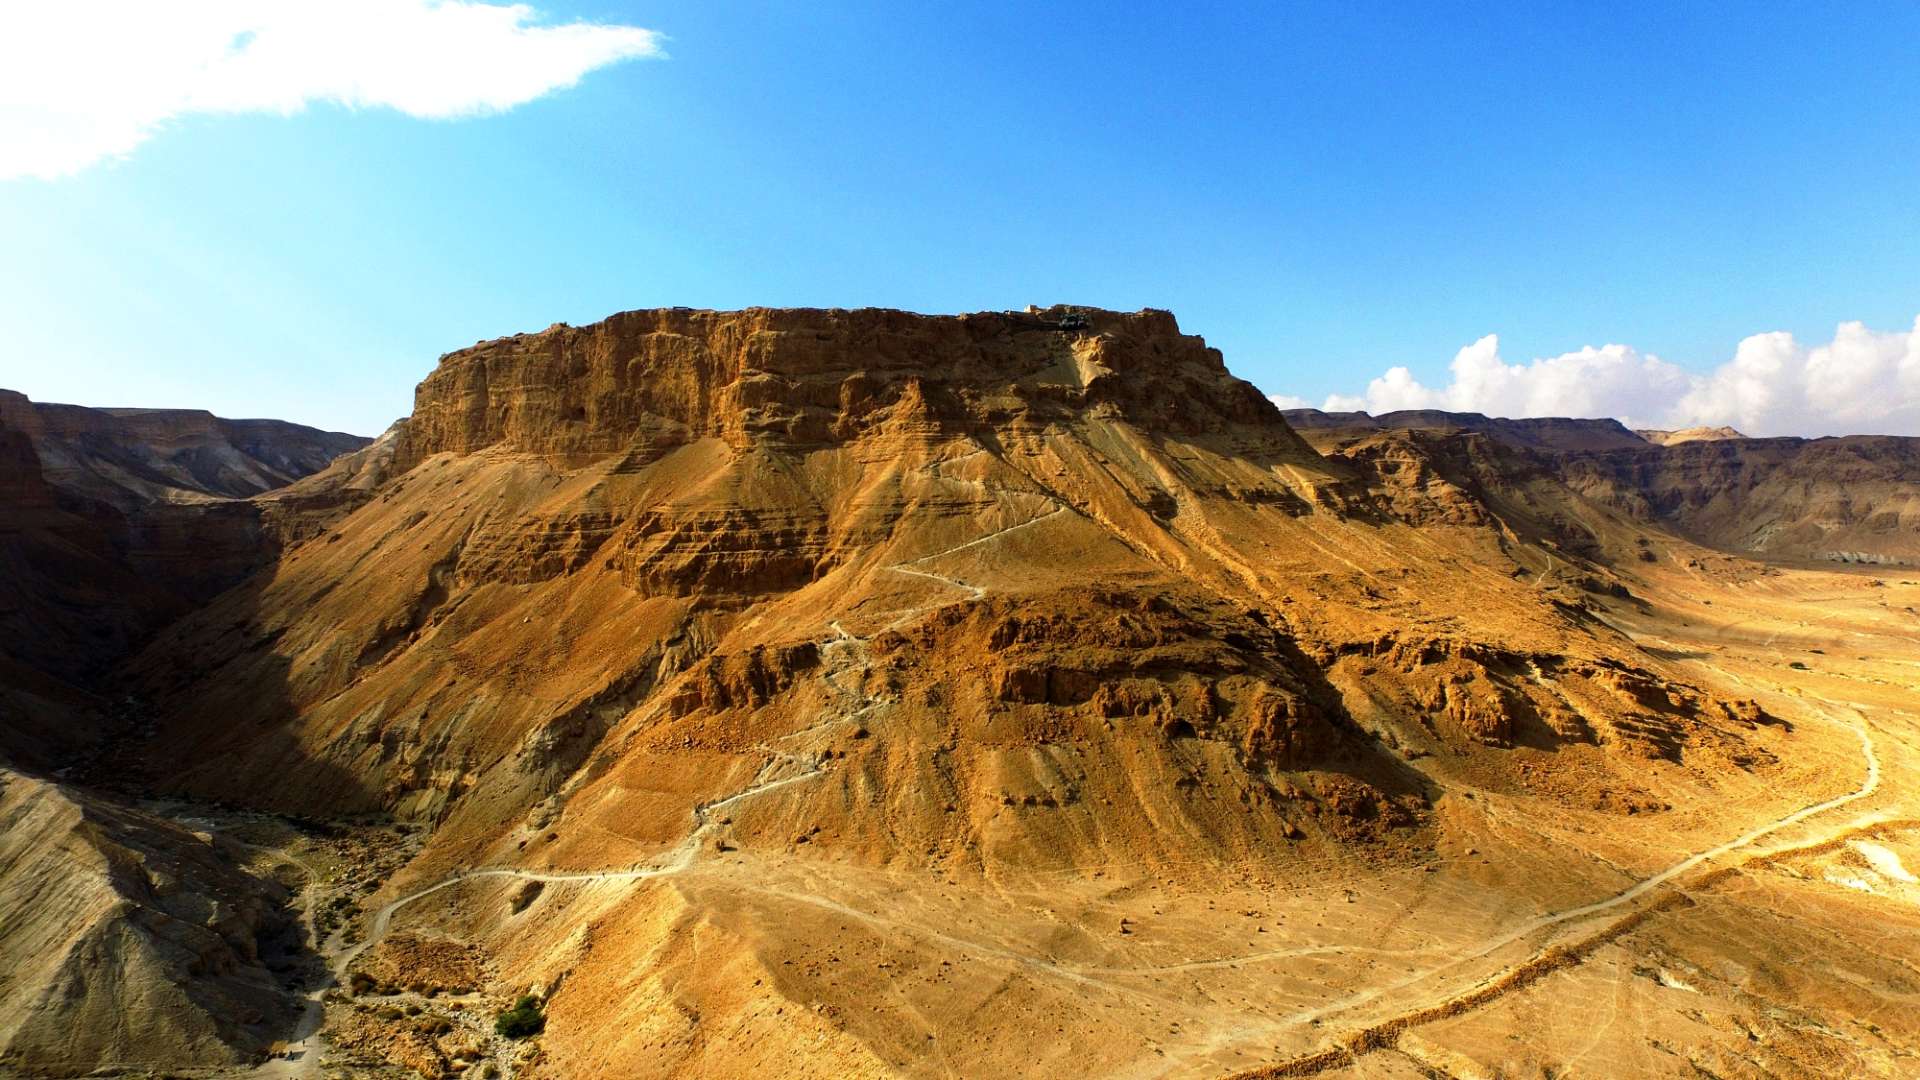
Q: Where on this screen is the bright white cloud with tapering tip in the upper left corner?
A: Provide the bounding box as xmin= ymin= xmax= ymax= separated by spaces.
xmin=0 ymin=0 xmax=664 ymax=179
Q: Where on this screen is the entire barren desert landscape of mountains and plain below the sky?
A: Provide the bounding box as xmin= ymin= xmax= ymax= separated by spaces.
xmin=0 ymin=307 xmax=1920 ymax=1078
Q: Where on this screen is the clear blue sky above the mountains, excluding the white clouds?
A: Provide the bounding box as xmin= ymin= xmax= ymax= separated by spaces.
xmin=0 ymin=2 xmax=1920 ymax=432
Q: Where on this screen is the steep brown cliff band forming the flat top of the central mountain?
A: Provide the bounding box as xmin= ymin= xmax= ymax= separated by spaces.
xmin=403 ymin=306 xmax=1311 ymax=463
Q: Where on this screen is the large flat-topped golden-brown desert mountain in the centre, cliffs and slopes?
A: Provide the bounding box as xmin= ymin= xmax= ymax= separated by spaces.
xmin=132 ymin=311 xmax=1766 ymax=841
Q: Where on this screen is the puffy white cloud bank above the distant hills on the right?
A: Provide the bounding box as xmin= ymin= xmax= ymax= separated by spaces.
xmin=1288 ymin=319 xmax=1920 ymax=434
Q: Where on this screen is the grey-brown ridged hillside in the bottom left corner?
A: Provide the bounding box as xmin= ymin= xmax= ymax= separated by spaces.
xmin=0 ymin=769 xmax=294 ymax=1076
